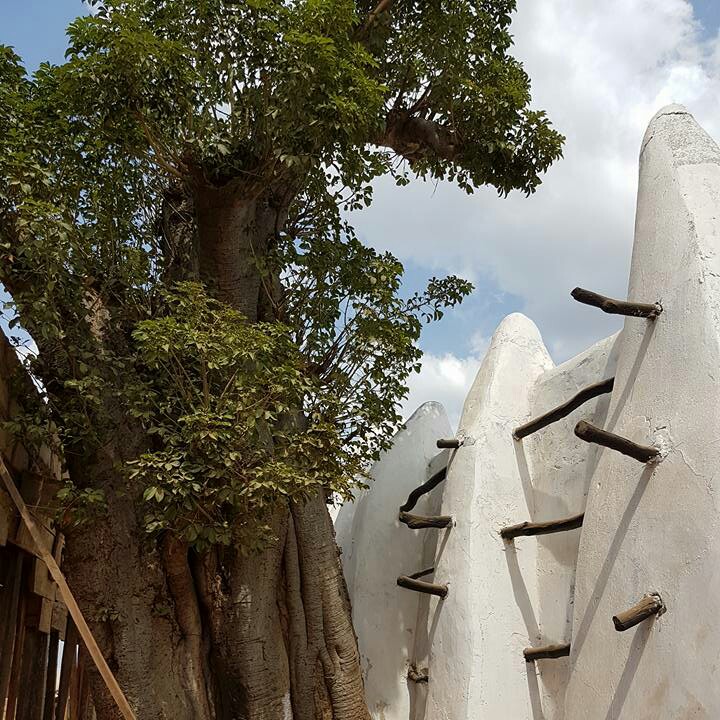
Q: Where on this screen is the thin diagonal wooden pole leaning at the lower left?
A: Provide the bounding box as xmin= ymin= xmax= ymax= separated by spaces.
xmin=0 ymin=457 xmax=137 ymax=720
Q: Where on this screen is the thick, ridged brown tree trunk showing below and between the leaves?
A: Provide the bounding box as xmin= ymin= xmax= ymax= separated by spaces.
xmin=58 ymin=180 xmax=369 ymax=720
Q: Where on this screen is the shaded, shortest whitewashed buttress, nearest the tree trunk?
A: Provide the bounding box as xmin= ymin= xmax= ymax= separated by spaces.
xmin=336 ymin=403 xmax=451 ymax=720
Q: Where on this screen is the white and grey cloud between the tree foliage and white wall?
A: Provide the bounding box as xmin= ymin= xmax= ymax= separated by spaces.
xmin=356 ymin=0 xmax=720 ymax=412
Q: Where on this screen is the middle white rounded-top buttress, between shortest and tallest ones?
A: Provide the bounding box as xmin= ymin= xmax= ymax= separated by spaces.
xmin=426 ymin=314 xmax=552 ymax=720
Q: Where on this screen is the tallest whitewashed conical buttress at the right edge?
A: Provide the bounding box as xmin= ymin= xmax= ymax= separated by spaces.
xmin=566 ymin=106 xmax=720 ymax=720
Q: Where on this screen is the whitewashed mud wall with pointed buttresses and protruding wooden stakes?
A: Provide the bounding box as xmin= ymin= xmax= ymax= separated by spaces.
xmin=338 ymin=106 xmax=720 ymax=720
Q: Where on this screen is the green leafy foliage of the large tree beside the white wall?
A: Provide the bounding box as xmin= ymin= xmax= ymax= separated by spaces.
xmin=0 ymin=0 xmax=562 ymax=549
